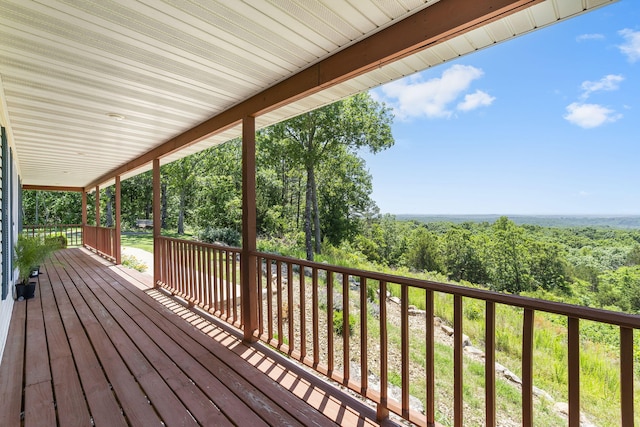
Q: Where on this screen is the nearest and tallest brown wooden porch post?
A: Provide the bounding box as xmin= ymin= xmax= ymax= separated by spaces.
xmin=240 ymin=116 xmax=258 ymax=342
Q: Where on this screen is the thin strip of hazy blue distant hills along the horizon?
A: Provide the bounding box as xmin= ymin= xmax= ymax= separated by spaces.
xmin=395 ymin=214 xmax=640 ymax=229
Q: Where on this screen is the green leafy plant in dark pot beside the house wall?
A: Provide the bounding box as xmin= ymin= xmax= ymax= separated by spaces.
xmin=13 ymin=234 xmax=60 ymax=301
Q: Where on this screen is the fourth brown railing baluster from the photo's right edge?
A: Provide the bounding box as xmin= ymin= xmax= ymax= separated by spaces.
xmin=484 ymin=301 xmax=496 ymax=427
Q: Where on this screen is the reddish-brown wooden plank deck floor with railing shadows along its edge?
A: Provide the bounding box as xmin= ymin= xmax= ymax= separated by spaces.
xmin=0 ymin=248 xmax=395 ymax=427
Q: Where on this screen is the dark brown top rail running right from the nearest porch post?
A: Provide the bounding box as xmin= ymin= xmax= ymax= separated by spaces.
xmin=255 ymin=252 xmax=640 ymax=329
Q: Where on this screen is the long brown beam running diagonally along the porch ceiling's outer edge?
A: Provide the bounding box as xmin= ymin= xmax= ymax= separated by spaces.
xmin=86 ymin=0 xmax=544 ymax=188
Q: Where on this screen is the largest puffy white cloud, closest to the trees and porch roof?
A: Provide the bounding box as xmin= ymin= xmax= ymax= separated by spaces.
xmin=381 ymin=65 xmax=495 ymax=120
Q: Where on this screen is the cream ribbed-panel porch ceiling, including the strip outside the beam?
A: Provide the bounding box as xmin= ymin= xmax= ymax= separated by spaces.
xmin=0 ymin=0 xmax=615 ymax=191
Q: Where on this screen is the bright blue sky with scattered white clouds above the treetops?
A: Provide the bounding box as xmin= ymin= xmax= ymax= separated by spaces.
xmin=363 ymin=0 xmax=640 ymax=215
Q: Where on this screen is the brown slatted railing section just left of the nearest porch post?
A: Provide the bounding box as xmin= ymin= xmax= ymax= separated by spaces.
xmin=154 ymin=237 xmax=242 ymax=327
